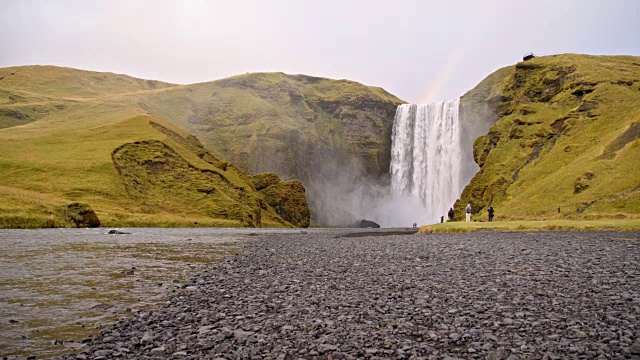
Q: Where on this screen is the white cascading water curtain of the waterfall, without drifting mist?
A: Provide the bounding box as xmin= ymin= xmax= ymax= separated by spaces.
xmin=390 ymin=100 xmax=464 ymax=223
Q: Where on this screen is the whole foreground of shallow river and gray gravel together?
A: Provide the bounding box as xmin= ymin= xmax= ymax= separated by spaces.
xmin=0 ymin=229 xmax=640 ymax=360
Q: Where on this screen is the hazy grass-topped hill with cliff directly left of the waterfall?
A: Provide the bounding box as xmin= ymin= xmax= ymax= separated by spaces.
xmin=139 ymin=73 xmax=402 ymax=184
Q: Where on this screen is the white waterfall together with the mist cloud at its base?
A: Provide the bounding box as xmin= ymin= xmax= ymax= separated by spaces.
xmin=309 ymin=100 xmax=488 ymax=227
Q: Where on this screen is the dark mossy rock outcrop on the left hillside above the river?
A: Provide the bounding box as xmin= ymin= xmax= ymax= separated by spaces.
xmin=113 ymin=136 xmax=308 ymax=227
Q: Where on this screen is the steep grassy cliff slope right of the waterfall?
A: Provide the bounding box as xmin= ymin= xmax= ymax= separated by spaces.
xmin=456 ymin=55 xmax=640 ymax=220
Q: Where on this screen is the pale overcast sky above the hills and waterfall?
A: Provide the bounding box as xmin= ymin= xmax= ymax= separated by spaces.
xmin=0 ymin=0 xmax=640 ymax=103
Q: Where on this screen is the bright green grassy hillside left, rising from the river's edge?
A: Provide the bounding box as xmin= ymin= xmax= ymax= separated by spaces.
xmin=0 ymin=67 xmax=309 ymax=227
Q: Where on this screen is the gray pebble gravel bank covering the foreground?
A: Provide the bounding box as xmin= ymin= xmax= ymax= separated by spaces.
xmin=63 ymin=231 xmax=640 ymax=360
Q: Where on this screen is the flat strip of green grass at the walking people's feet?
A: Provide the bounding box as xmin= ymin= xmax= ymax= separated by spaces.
xmin=418 ymin=219 xmax=640 ymax=235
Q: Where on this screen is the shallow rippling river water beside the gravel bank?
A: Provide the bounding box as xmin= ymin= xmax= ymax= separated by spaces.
xmin=0 ymin=228 xmax=310 ymax=358
